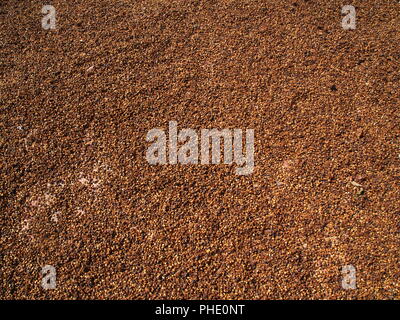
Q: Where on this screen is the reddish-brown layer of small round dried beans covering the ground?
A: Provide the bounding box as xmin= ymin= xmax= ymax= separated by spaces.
xmin=0 ymin=0 xmax=400 ymax=299
